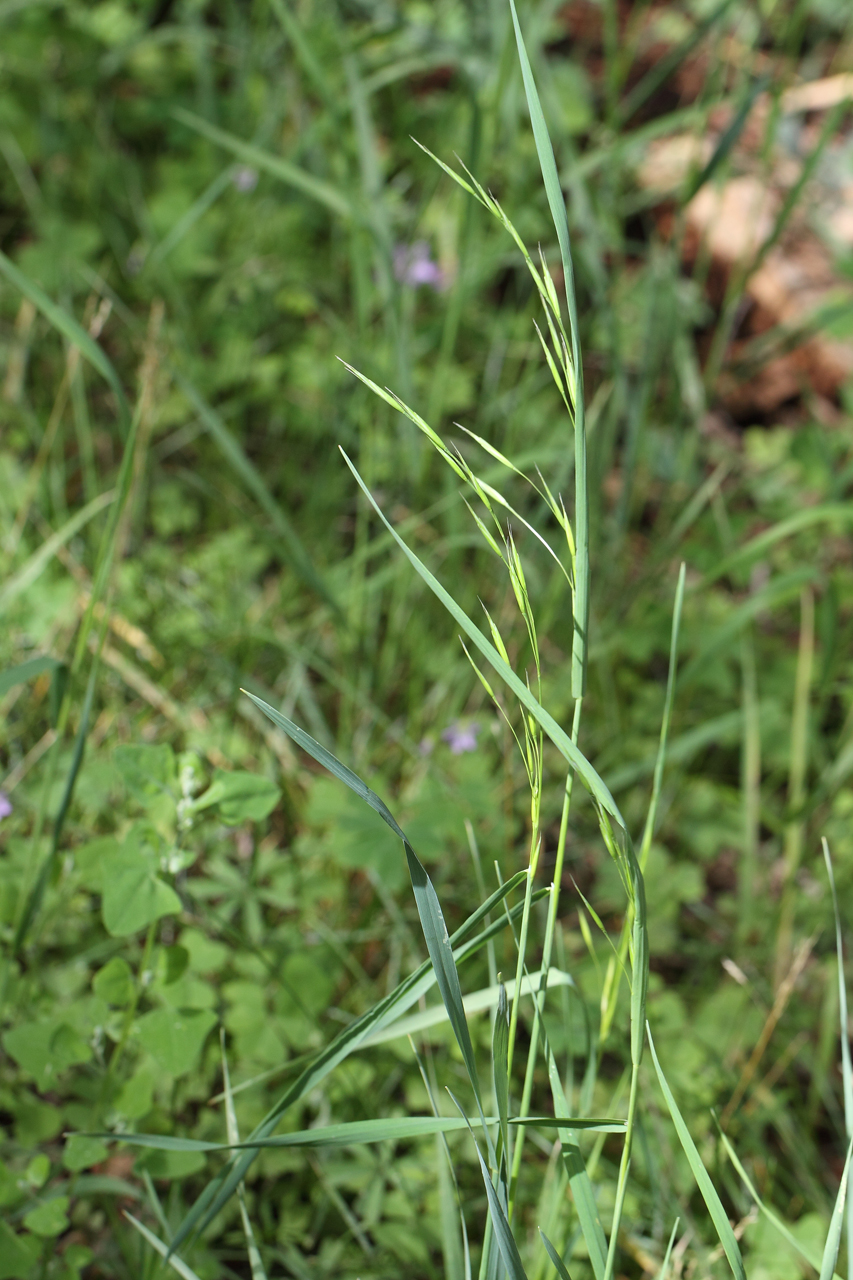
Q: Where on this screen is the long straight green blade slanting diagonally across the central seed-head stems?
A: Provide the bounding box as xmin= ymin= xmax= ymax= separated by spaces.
xmin=341 ymin=449 xmax=625 ymax=831
